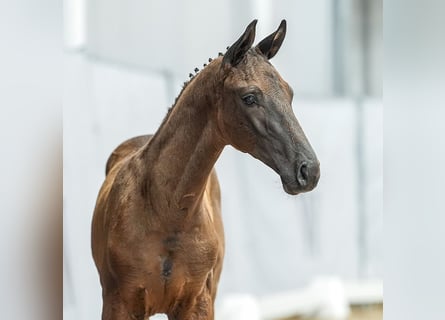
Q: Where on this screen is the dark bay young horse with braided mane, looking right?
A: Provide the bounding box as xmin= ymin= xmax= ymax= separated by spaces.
xmin=92 ymin=20 xmax=320 ymax=320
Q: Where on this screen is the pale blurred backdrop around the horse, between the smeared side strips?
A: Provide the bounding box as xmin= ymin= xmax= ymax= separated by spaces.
xmin=63 ymin=0 xmax=383 ymax=319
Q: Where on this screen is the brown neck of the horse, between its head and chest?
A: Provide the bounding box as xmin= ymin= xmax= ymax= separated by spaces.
xmin=141 ymin=65 xmax=224 ymax=210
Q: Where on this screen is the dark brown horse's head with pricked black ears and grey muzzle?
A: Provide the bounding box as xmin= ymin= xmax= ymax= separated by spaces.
xmin=217 ymin=20 xmax=320 ymax=195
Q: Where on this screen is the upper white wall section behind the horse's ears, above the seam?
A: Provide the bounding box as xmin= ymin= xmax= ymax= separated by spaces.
xmin=86 ymin=0 xmax=332 ymax=95
